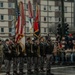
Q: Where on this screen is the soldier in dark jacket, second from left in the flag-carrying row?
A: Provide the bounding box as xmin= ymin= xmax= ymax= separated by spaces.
xmin=10 ymin=39 xmax=18 ymax=75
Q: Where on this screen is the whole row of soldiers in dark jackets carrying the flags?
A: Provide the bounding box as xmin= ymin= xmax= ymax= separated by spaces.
xmin=3 ymin=37 xmax=53 ymax=75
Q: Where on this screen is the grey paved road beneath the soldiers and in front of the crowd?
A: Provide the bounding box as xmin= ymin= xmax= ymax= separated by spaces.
xmin=0 ymin=65 xmax=75 ymax=75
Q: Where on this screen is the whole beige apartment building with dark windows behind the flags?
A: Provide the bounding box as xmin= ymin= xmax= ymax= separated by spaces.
xmin=0 ymin=0 xmax=74 ymax=38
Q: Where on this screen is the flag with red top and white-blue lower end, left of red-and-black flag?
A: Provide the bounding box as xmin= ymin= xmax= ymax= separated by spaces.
xmin=28 ymin=0 xmax=33 ymax=32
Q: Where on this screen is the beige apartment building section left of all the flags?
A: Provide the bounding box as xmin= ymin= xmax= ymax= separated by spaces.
xmin=0 ymin=0 xmax=15 ymax=38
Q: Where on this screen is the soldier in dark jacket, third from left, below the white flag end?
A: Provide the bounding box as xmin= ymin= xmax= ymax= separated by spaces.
xmin=16 ymin=42 xmax=24 ymax=75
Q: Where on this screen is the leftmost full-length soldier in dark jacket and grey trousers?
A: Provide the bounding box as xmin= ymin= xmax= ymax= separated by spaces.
xmin=3 ymin=39 xmax=12 ymax=75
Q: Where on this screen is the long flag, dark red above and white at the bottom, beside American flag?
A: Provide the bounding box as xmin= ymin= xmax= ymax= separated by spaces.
xmin=19 ymin=1 xmax=26 ymax=51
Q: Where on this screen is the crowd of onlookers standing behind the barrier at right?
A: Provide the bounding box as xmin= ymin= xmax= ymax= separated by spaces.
xmin=53 ymin=35 xmax=75 ymax=64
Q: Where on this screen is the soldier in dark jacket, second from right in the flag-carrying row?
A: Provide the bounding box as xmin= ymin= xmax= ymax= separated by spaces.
xmin=39 ymin=37 xmax=46 ymax=71
